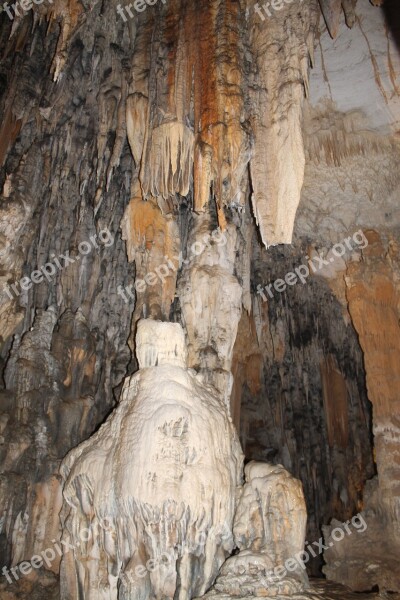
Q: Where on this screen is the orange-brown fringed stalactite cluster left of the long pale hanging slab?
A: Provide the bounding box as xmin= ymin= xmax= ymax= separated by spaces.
xmin=128 ymin=0 xmax=250 ymax=229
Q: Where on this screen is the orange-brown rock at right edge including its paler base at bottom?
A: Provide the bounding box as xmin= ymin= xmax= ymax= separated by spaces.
xmin=324 ymin=230 xmax=400 ymax=591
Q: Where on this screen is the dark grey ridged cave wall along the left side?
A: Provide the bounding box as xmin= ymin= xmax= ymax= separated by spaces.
xmin=0 ymin=4 xmax=135 ymax=570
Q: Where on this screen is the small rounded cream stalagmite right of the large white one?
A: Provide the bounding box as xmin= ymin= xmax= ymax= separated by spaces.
xmin=205 ymin=461 xmax=308 ymax=597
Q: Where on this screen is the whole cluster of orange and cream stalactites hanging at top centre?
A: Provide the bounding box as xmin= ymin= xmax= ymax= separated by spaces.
xmin=123 ymin=0 xmax=319 ymax=246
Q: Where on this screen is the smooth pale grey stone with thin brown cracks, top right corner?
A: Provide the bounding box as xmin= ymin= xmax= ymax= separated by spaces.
xmin=310 ymin=0 xmax=400 ymax=134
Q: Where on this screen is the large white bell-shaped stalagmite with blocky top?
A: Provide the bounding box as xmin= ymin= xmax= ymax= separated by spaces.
xmin=61 ymin=320 xmax=243 ymax=600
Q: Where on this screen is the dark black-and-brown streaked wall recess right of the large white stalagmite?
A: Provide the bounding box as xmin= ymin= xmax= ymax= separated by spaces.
xmin=235 ymin=246 xmax=374 ymax=570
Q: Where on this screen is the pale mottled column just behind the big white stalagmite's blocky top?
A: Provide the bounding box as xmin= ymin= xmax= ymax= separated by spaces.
xmin=178 ymin=215 xmax=244 ymax=405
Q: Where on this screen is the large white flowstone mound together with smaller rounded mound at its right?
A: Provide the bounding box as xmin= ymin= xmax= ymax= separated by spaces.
xmin=61 ymin=320 xmax=308 ymax=600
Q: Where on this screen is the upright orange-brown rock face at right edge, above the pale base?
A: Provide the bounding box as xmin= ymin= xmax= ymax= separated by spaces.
xmin=346 ymin=231 xmax=400 ymax=510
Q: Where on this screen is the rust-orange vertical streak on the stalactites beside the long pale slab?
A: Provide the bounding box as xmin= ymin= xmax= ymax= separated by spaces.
xmin=192 ymin=0 xmax=246 ymax=219
